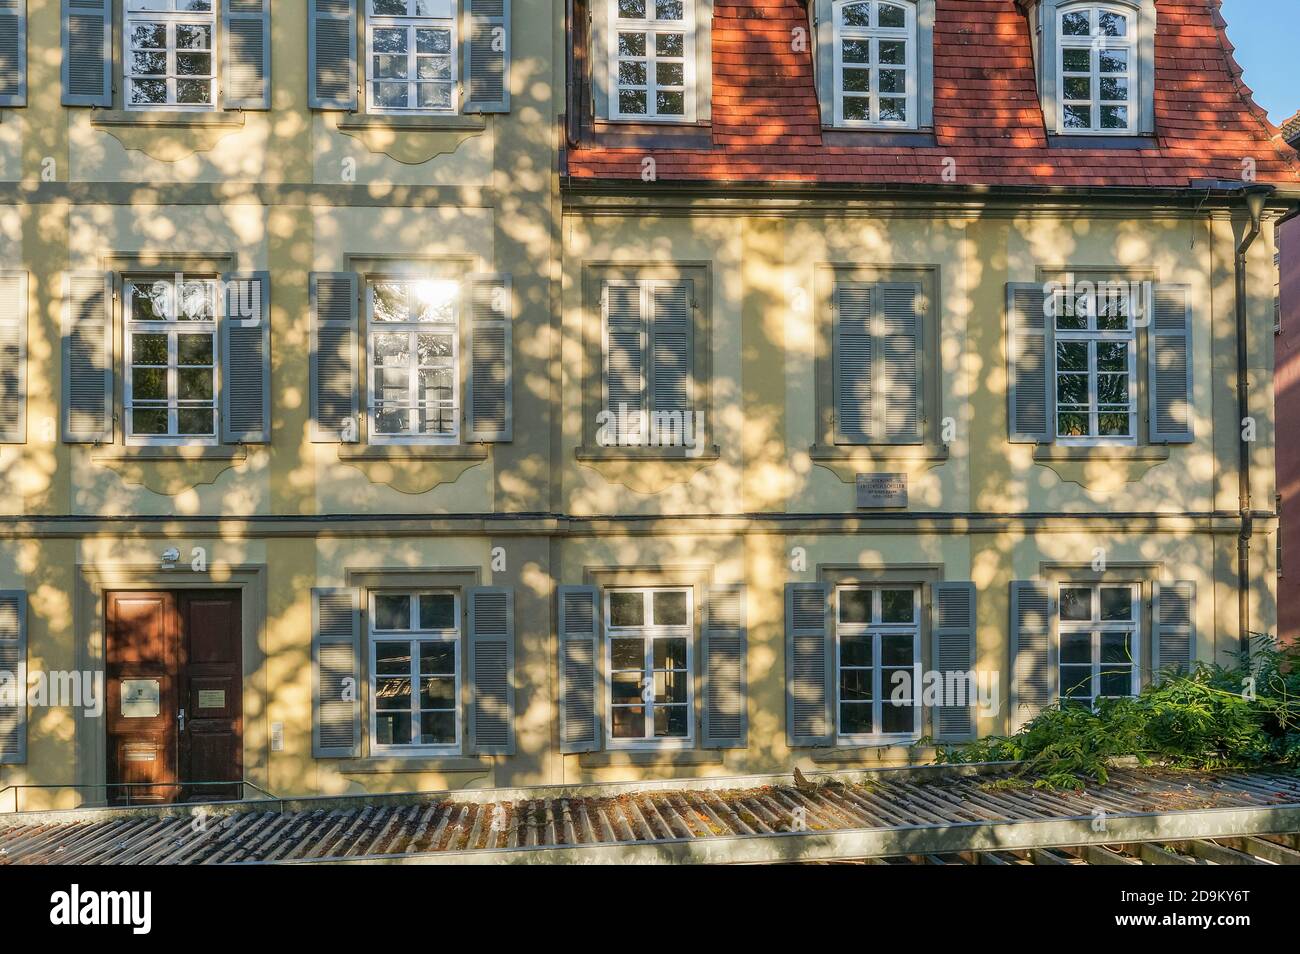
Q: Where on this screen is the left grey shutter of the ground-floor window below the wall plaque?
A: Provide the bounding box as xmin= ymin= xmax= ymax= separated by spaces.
xmin=785 ymin=584 xmax=835 ymax=749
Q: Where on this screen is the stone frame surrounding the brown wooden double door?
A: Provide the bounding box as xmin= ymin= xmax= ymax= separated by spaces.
xmin=73 ymin=564 xmax=266 ymax=799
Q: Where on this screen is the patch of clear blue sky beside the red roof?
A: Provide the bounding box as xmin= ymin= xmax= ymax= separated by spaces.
xmin=1223 ymin=0 xmax=1300 ymax=122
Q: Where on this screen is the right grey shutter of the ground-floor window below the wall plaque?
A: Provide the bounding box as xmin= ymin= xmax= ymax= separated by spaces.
xmin=931 ymin=582 xmax=975 ymax=742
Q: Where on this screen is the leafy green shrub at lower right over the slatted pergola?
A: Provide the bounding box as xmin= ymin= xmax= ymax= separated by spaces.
xmin=918 ymin=636 xmax=1300 ymax=789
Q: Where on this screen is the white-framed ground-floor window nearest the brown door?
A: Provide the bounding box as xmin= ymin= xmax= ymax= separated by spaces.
xmin=367 ymin=590 xmax=462 ymax=753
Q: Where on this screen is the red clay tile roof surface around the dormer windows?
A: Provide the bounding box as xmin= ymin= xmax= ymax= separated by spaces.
xmin=567 ymin=0 xmax=1300 ymax=188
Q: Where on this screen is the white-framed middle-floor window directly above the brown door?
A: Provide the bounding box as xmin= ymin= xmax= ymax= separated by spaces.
xmin=122 ymin=276 xmax=220 ymax=445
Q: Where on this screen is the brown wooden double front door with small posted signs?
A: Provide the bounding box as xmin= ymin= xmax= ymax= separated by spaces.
xmin=107 ymin=590 xmax=243 ymax=803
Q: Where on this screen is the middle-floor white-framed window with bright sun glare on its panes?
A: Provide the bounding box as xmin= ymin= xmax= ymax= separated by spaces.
xmin=365 ymin=277 xmax=460 ymax=445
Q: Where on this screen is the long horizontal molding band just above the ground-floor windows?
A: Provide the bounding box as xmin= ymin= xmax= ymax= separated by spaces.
xmin=0 ymin=511 xmax=1275 ymax=539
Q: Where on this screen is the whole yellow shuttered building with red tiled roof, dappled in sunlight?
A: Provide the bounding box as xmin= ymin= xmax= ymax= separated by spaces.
xmin=0 ymin=0 xmax=1300 ymax=810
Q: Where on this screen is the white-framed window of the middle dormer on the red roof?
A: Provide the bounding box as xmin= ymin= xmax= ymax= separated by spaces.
xmin=832 ymin=0 xmax=917 ymax=129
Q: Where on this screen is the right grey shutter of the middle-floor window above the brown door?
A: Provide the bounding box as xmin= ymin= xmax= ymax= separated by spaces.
xmin=221 ymin=272 xmax=270 ymax=445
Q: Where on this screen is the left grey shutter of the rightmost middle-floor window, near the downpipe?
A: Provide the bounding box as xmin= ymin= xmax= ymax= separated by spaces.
xmin=1006 ymin=282 xmax=1056 ymax=443
